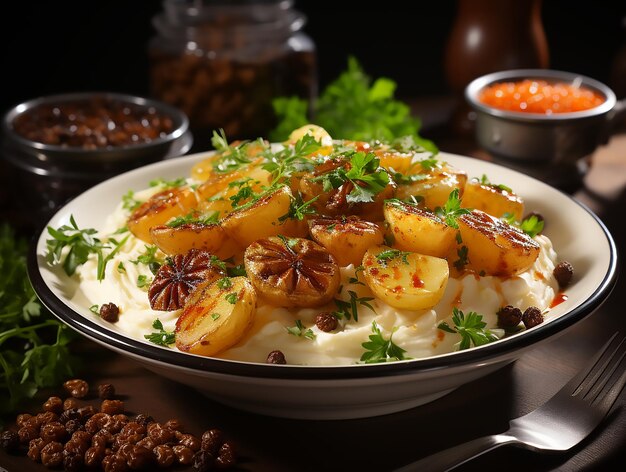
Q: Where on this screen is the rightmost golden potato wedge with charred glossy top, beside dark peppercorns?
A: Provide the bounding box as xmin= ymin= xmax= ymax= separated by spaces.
xmin=457 ymin=210 xmax=540 ymax=277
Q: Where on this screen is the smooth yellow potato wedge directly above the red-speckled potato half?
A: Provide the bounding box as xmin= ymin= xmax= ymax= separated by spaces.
xmin=384 ymin=200 xmax=456 ymax=258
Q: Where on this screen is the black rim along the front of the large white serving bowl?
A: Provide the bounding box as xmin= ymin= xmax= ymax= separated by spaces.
xmin=28 ymin=197 xmax=618 ymax=380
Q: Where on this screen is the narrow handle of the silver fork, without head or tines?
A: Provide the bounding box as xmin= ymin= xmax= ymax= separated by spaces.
xmin=395 ymin=434 xmax=518 ymax=472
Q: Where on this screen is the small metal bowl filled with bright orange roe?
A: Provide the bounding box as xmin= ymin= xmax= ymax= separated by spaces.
xmin=465 ymin=69 xmax=626 ymax=167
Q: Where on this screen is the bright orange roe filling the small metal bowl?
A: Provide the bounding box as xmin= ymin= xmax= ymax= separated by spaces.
xmin=478 ymin=79 xmax=605 ymax=115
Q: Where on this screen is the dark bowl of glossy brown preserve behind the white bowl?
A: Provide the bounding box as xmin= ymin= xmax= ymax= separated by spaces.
xmin=2 ymin=92 xmax=193 ymax=225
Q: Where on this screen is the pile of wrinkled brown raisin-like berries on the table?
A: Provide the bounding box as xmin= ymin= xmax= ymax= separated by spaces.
xmin=0 ymin=379 xmax=237 ymax=472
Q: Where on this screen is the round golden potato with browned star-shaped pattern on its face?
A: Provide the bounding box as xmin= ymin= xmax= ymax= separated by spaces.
xmin=244 ymin=236 xmax=341 ymax=307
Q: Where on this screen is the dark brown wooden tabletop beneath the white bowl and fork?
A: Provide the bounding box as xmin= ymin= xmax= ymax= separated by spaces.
xmin=0 ymin=101 xmax=626 ymax=472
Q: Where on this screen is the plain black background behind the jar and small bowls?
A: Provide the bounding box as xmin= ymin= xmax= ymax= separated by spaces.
xmin=0 ymin=0 xmax=626 ymax=116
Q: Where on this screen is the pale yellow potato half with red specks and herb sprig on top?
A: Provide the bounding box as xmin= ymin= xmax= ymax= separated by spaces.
xmin=363 ymin=246 xmax=449 ymax=310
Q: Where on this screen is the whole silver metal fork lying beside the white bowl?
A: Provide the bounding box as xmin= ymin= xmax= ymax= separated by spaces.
xmin=396 ymin=333 xmax=626 ymax=472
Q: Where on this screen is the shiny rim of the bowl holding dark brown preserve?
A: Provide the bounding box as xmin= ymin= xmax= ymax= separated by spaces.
xmin=2 ymin=91 xmax=189 ymax=154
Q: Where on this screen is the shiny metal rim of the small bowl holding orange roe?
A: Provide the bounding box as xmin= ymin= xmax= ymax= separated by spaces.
xmin=465 ymin=69 xmax=617 ymax=123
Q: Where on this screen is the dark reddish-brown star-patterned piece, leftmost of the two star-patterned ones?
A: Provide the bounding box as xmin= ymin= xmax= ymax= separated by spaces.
xmin=148 ymin=249 xmax=226 ymax=311
